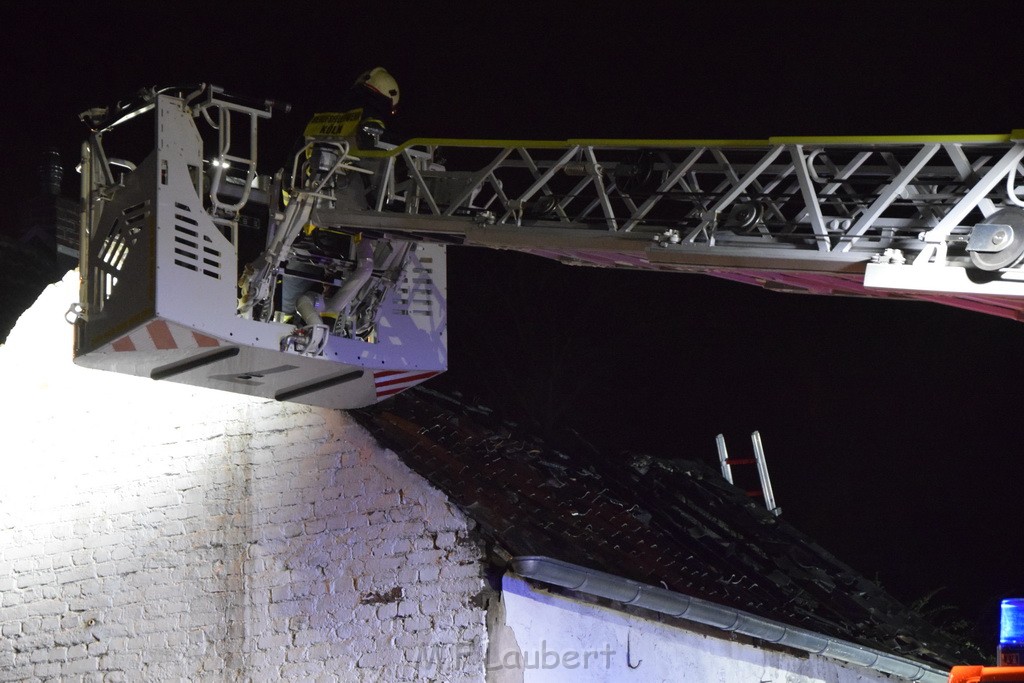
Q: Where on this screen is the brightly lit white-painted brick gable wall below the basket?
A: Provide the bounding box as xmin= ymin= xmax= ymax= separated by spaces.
xmin=0 ymin=276 xmax=486 ymax=681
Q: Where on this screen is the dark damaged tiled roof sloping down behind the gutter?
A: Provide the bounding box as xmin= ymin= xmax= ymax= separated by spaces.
xmin=351 ymin=387 xmax=979 ymax=667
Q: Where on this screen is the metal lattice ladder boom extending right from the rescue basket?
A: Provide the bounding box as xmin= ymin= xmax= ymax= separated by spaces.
xmin=314 ymin=131 xmax=1024 ymax=319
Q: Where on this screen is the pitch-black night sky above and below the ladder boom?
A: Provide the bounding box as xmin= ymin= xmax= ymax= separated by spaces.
xmin=0 ymin=1 xmax=1024 ymax=651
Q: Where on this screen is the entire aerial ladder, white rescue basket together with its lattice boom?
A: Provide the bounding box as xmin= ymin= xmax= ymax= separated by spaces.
xmin=75 ymin=86 xmax=1024 ymax=408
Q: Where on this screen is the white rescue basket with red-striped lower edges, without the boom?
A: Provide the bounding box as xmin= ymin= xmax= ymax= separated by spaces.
xmin=75 ymin=84 xmax=447 ymax=408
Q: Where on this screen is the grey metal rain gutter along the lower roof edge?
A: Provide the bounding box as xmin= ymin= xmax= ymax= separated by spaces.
xmin=512 ymin=556 xmax=948 ymax=683
